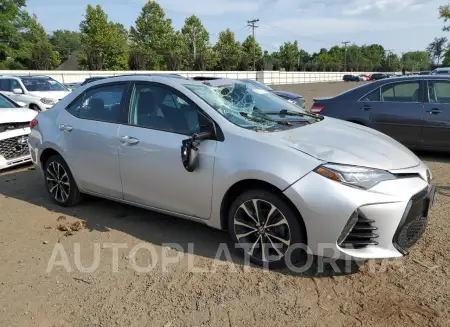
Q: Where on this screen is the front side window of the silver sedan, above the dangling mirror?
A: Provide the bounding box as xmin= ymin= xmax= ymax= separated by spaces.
xmin=129 ymin=84 xmax=200 ymax=135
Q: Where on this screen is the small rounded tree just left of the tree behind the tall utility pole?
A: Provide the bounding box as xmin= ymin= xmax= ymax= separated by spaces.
xmin=214 ymin=28 xmax=241 ymax=70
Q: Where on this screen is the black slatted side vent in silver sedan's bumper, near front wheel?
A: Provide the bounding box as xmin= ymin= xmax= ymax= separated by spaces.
xmin=339 ymin=210 xmax=379 ymax=249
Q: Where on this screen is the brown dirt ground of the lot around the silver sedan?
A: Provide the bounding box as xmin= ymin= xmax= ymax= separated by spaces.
xmin=0 ymin=83 xmax=450 ymax=327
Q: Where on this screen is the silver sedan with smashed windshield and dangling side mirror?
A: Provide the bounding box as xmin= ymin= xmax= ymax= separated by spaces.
xmin=29 ymin=76 xmax=435 ymax=268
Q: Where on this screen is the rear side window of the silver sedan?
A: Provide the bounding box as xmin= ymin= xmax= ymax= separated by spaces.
xmin=66 ymin=83 xmax=126 ymax=123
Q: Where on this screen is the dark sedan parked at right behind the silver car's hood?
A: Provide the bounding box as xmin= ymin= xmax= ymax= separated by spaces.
xmin=311 ymin=75 xmax=450 ymax=151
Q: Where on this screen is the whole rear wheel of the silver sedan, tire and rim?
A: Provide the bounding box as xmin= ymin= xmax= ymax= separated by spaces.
xmin=44 ymin=155 xmax=81 ymax=207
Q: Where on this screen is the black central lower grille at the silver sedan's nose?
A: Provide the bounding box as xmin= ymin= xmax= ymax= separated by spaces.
xmin=393 ymin=188 xmax=431 ymax=254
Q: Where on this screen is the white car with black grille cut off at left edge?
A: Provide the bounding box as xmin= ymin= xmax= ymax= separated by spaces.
xmin=0 ymin=94 xmax=37 ymax=170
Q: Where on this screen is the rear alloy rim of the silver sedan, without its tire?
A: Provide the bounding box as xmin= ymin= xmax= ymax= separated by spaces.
xmin=45 ymin=161 xmax=70 ymax=202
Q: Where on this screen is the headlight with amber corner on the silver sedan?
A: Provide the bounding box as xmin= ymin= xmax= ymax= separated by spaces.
xmin=314 ymin=163 xmax=396 ymax=190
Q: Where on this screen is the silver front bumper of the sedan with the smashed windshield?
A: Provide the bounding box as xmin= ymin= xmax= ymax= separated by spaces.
xmin=284 ymin=164 xmax=435 ymax=259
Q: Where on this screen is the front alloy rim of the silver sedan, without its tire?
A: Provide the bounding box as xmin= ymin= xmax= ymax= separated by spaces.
xmin=234 ymin=199 xmax=291 ymax=263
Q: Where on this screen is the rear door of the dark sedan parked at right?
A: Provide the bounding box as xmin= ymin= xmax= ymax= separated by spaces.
xmin=362 ymin=80 xmax=424 ymax=147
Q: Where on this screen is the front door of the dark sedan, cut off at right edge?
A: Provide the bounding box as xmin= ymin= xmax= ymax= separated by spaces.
xmin=423 ymin=80 xmax=450 ymax=149
